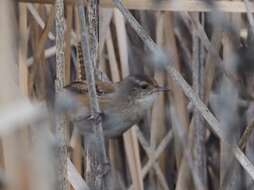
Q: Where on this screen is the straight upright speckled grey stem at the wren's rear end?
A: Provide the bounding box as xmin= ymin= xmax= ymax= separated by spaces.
xmin=55 ymin=0 xmax=68 ymax=190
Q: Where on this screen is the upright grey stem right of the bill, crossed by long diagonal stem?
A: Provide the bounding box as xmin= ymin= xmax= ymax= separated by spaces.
xmin=190 ymin=14 xmax=207 ymax=190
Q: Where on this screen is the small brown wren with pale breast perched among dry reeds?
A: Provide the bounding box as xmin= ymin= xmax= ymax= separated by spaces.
xmin=62 ymin=75 xmax=168 ymax=138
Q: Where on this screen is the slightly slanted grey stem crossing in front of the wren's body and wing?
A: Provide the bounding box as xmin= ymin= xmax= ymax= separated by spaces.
xmin=77 ymin=0 xmax=108 ymax=190
